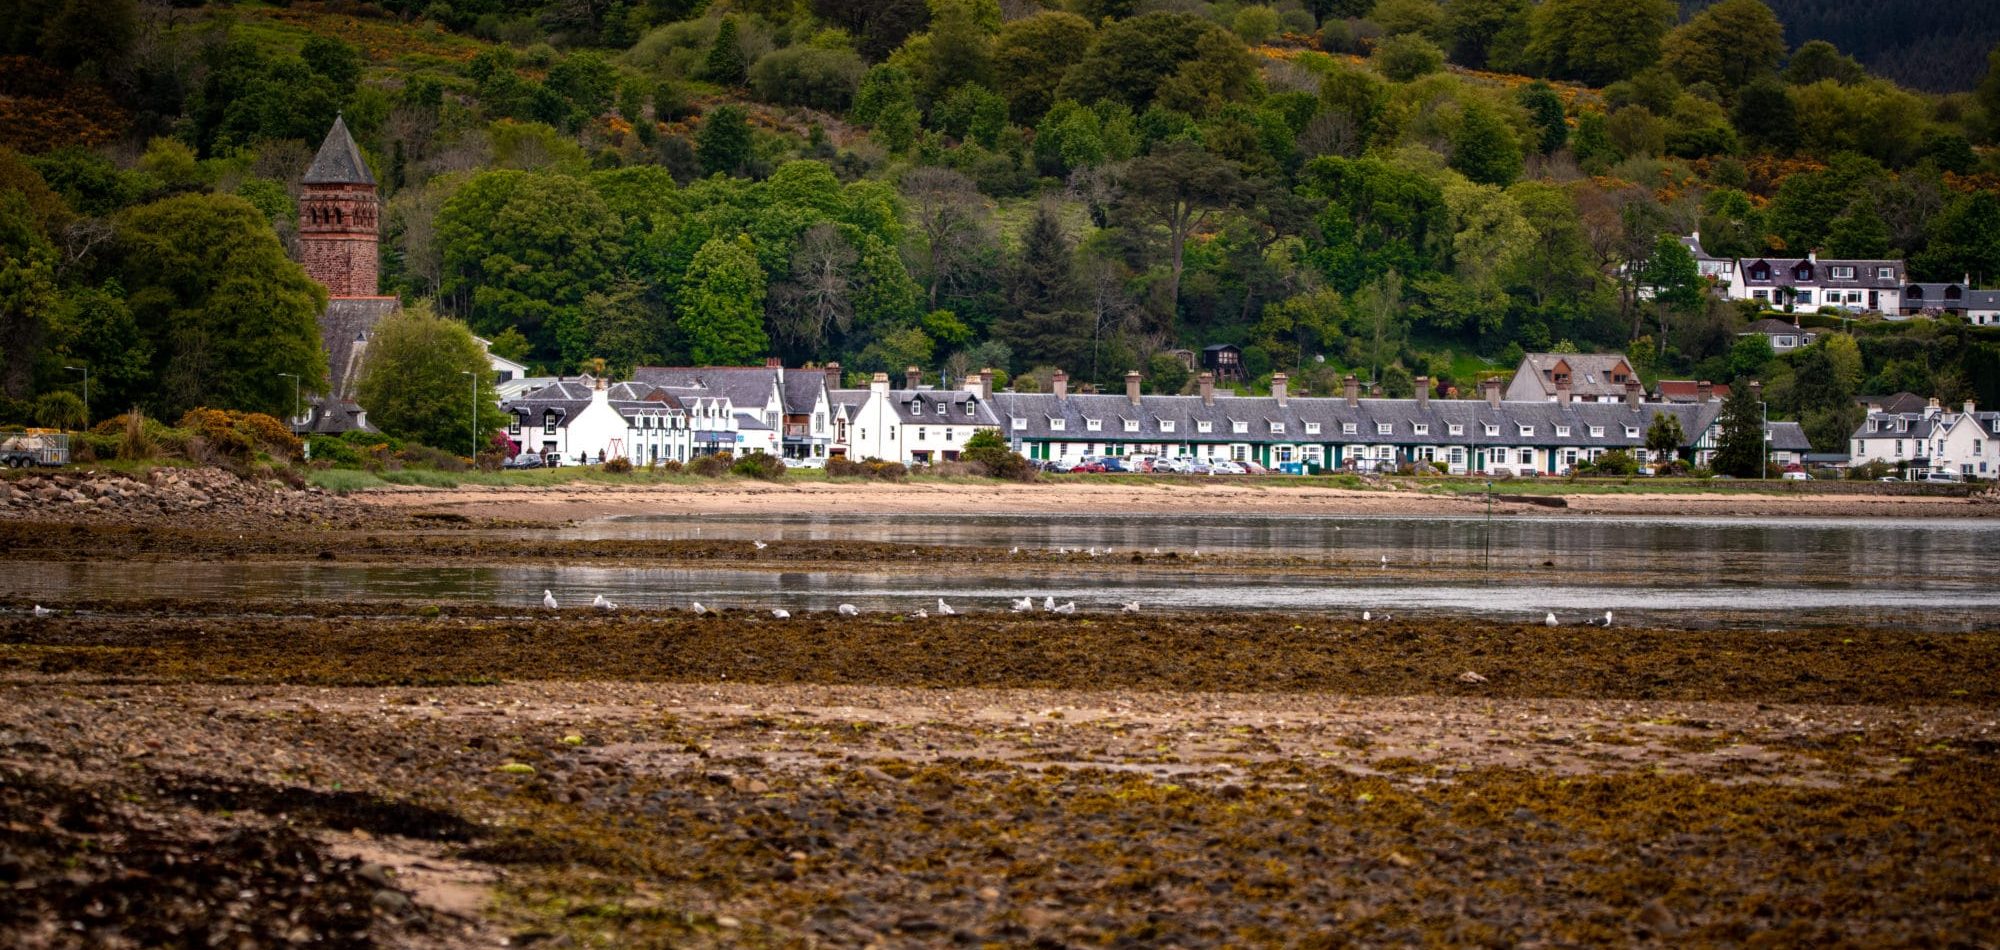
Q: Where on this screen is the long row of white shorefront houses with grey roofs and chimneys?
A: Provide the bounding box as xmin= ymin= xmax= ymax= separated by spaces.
xmin=502 ymin=354 xmax=1808 ymax=474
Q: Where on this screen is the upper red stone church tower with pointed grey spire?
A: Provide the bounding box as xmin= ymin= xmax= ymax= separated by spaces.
xmin=298 ymin=118 xmax=380 ymax=296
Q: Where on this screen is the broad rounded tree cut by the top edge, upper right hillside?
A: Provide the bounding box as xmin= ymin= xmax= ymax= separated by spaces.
xmin=1526 ymin=0 xmax=1678 ymax=86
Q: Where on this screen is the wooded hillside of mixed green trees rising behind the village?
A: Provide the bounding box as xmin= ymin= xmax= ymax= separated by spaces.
xmin=0 ymin=0 xmax=2000 ymax=456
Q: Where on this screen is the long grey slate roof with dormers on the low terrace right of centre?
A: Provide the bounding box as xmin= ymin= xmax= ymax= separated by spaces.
xmin=992 ymin=392 xmax=1722 ymax=448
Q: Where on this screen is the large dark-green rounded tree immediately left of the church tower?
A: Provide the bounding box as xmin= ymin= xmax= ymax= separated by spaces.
xmin=116 ymin=194 xmax=326 ymax=418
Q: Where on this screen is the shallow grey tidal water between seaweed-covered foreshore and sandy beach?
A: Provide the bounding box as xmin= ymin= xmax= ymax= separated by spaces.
xmin=0 ymin=512 xmax=2000 ymax=630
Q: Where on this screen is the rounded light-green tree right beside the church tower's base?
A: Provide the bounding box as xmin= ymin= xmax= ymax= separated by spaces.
xmin=354 ymin=302 xmax=500 ymax=456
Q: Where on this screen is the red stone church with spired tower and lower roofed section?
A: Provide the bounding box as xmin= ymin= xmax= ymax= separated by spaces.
xmin=294 ymin=118 xmax=402 ymax=434
